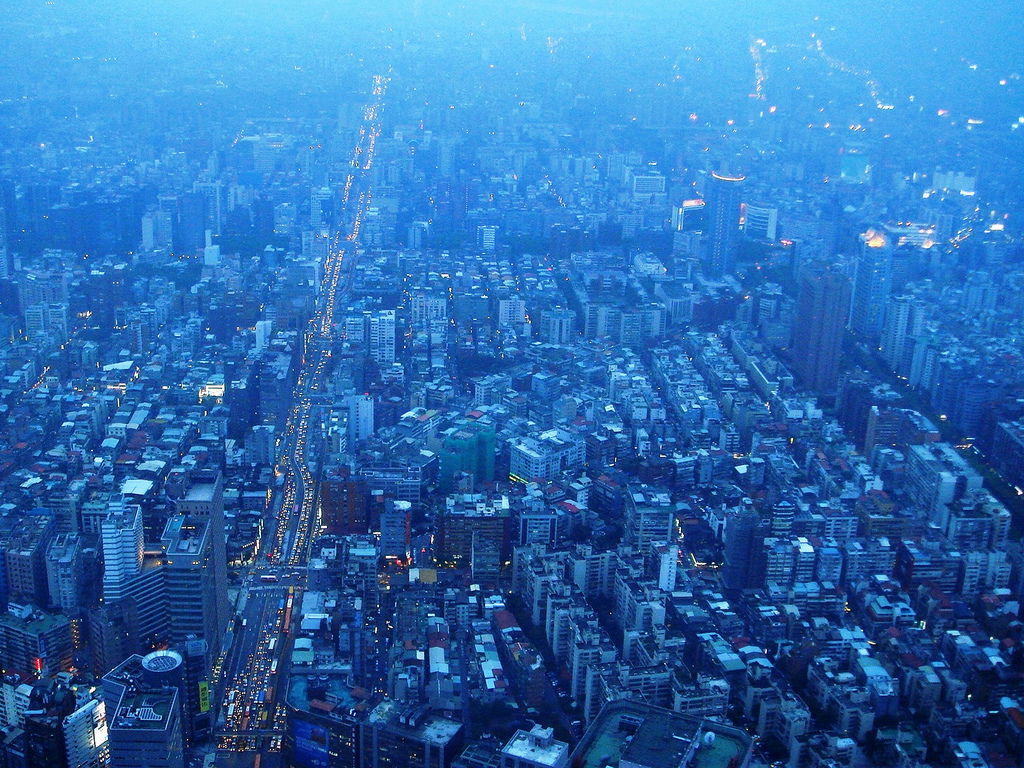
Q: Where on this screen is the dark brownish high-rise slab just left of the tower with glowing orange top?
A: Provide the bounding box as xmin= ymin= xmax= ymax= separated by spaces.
xmin=793 ymin=267 xmax=850 ymax=392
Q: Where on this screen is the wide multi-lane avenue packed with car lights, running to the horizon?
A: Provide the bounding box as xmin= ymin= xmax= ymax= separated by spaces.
xmin=217 ymin=76 xmax=388 ymax=768
